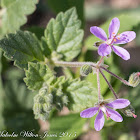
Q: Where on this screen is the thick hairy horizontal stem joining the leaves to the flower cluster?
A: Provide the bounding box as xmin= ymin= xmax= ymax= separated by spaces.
xmin=54 ymin=61 xmax=96 ymax=67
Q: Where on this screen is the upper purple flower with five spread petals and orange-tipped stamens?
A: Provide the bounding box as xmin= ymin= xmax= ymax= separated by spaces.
xmin=90 ymin=18 xmax=136 ymax=60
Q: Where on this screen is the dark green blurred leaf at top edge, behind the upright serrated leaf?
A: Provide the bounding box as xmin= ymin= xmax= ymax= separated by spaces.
xmin=47 ymin=0 xmax=85 ymax=27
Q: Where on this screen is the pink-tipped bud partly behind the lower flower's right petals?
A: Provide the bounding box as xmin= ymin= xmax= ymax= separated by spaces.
xmin=121 ymin=105 xmax=137 ymax=118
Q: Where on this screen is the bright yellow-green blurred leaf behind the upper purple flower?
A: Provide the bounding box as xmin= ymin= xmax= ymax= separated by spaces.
xmin=85 ymin=12 xmax=140 ymax=50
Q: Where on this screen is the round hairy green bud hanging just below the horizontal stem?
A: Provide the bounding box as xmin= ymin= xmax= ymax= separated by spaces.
xmin=80 ymin=65 xmax=93 ymax=76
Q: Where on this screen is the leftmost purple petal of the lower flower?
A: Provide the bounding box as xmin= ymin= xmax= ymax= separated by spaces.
xmin=80 ymin=107 xmax=99 ymax=118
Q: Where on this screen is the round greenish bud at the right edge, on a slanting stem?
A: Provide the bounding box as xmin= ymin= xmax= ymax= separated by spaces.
xmin=128 ymin=72 xmax=140 ymax=87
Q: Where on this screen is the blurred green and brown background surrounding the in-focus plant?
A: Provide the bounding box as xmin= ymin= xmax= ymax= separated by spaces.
xmin=0 ymin=0 xmax=140 ymax=140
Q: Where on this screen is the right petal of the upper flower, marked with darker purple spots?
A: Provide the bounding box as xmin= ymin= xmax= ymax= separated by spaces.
xmin=113 ymin=31 xmax=136 ymax=44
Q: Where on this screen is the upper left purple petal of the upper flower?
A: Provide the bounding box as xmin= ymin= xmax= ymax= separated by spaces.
xmin=90 ymin=26 xmax=107 ymax=41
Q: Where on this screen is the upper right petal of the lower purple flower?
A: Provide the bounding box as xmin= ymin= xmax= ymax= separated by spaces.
xmin=106 ymin=99 xmax=130 ymax=109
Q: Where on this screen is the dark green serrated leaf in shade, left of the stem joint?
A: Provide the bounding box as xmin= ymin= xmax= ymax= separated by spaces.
xmin=0 ymin=31 xmax=44 ymax=68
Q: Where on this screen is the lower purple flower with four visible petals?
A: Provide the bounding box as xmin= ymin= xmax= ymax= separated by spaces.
xmin=80 ymin=99 xmax=130 ymax=131
